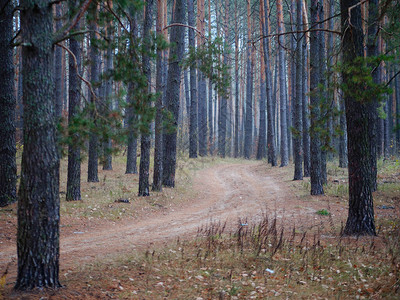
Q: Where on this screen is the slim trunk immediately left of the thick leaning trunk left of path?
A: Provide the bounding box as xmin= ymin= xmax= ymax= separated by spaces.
xmin=153 ymin=0 xmax=166 ymax=191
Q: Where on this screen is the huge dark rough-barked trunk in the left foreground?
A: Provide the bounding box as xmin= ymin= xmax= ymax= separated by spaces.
xmin=15 ymin=0 xmax=61 ymax=290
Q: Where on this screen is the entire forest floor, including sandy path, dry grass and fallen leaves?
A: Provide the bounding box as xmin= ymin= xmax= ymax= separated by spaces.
xmin=0 ymin=157 xmax=400 ymax=300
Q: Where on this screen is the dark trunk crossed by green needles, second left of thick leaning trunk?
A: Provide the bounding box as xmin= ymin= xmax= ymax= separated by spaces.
xmin=138 ymin=0 xmax=154 ymax=196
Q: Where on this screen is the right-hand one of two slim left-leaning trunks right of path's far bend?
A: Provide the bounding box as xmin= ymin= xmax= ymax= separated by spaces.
xmin=276 ymin=0 xmax=289 ymax=167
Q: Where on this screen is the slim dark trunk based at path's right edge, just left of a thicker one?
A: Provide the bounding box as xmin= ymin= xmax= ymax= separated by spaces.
xmin=292 ymin=0 xmax=304 ymax=180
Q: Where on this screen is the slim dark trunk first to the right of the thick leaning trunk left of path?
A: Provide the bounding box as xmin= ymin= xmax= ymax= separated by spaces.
xmin=187 ymin=0 xmax=198 ymax=158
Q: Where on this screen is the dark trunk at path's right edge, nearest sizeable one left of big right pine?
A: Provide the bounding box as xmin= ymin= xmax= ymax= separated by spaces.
xmin=310 ymin=0 xmax=324 ymax=195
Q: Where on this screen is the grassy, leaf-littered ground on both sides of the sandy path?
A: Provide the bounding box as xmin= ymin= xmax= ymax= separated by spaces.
xmin=0 ymin=157 xmax=400 ymax=299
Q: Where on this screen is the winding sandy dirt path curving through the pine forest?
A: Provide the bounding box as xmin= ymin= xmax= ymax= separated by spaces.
xmin=0 ymin=162 xmax=328 ymax=276
